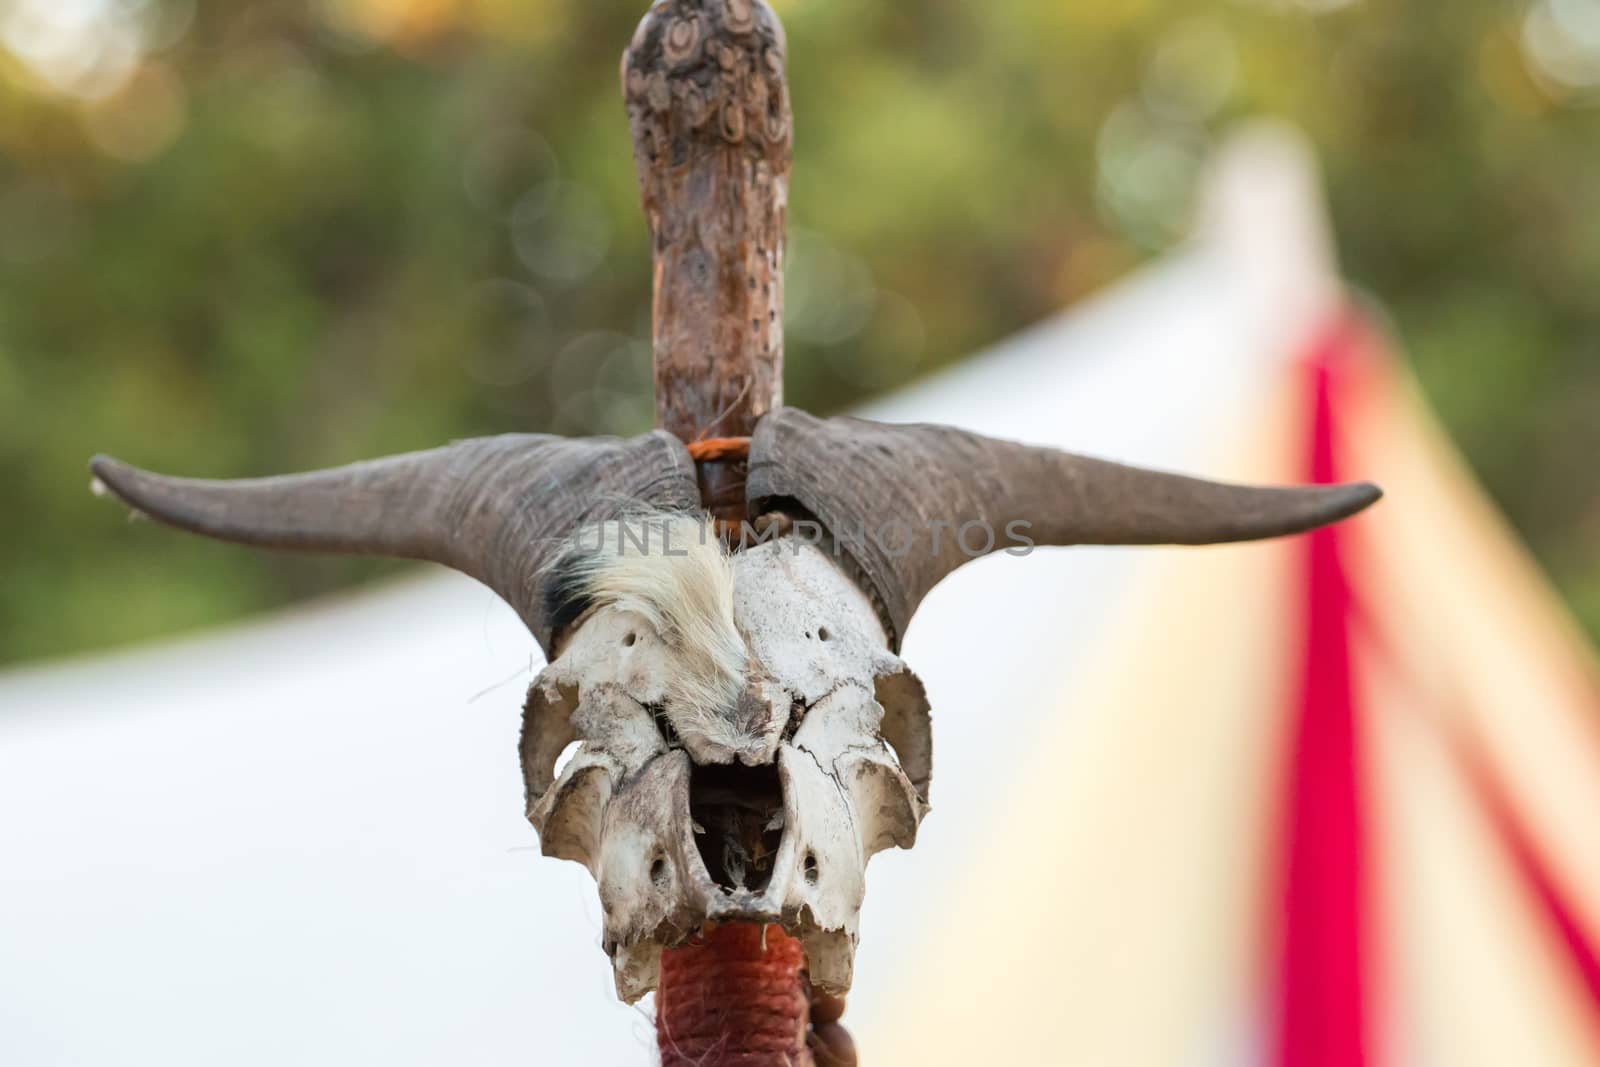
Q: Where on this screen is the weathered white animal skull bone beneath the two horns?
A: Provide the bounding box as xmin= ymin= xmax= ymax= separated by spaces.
xmin=522 ymin=520 xmax=930 ymax=1001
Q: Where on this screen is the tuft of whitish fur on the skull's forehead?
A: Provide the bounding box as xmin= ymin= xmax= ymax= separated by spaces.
xmin=565 ymin=512 xmax=746 ymax=744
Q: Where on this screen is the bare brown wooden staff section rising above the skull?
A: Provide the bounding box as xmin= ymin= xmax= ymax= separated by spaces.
xmin=622 ymin=0 xmax=794 ymax=522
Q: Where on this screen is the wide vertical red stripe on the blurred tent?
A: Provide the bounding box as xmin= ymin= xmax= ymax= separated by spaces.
xmin=1275 ymin=317 xmax=1368 ymax=1067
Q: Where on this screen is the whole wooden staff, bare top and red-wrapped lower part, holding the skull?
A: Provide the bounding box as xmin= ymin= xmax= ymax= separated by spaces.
xmin=622 ymin=0 xmax=856 ymax=1067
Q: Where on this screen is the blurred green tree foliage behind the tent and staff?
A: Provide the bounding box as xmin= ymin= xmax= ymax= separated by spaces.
xmin=0 ymin=0 xmax=1600 ymax=661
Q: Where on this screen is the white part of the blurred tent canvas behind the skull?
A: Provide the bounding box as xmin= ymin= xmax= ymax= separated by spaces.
xmin=0 ymin=130 xmax=1338 ymax=1067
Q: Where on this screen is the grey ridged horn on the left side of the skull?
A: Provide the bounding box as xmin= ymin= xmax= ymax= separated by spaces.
xmin=90 ymin=430 xmax=699 ymax=654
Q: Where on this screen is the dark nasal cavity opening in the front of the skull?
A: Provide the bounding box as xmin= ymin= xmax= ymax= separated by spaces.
xmin=690 ymin=763 xmax=784 ymax=893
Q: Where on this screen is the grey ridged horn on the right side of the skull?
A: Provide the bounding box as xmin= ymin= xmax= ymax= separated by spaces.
xmin=746 ymin=408 xmax=1382 ymax=648
